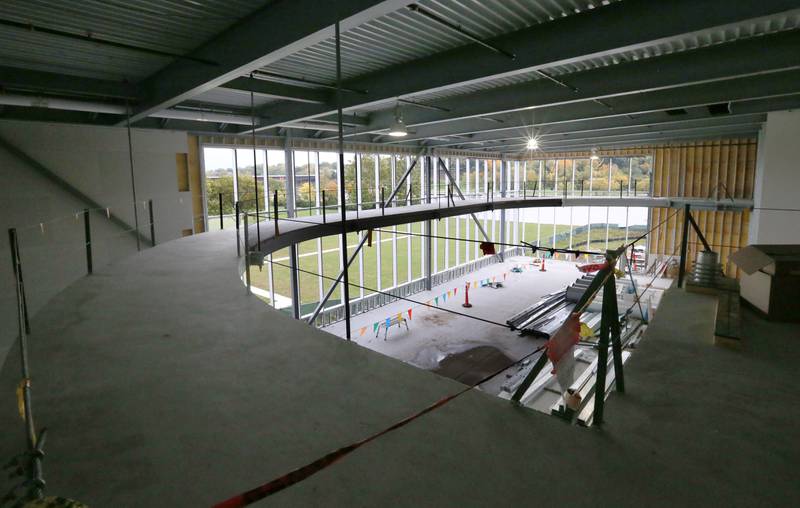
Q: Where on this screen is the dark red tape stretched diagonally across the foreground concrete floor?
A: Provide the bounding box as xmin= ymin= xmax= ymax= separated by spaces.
xmin=214 ymin=346 xmax=545 ymax=508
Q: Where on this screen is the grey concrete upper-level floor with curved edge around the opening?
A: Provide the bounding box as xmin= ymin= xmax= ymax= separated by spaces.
xmin=0 ymin=232 xmax=800 ymax=507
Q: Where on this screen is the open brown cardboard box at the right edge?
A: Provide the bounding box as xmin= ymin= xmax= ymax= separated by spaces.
xmin=730 ymin=245 xmax=800 ymax=321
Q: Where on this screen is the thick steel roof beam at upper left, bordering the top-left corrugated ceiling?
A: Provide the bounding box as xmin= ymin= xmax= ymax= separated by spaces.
xmin=126 ymin=0 xmax=407 ymax=121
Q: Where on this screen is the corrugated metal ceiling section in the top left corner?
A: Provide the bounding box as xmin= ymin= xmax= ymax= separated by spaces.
xmin=0 ymin=0 xmax=272 ymax=81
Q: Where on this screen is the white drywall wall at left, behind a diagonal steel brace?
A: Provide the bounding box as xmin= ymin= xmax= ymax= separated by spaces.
xmin=0 ymin=121 xmax=192 ymax=364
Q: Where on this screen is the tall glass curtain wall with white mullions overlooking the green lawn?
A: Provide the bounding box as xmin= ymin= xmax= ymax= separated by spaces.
xmin=203 ymin=146 xmax=652 ymax=315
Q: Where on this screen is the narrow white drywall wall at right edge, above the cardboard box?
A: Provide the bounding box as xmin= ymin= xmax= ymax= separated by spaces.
xmin=749 ymin=111 xmax=800 ymax=244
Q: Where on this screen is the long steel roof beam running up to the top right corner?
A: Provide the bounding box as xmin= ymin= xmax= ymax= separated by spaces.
xmin=248 ymin=0 xmax=798 ymax=133
